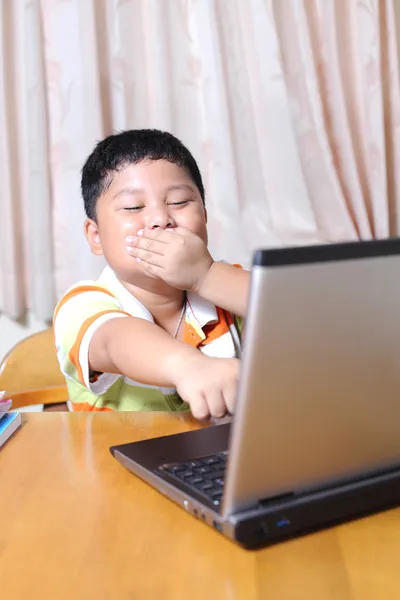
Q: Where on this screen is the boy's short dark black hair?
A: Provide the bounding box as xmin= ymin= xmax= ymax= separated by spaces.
xmin=81 ymin=129 xmax=205 ymax=220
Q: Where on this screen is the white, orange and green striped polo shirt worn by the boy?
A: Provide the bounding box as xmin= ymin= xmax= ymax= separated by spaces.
xmin=54 ymin=267 xmax=242 ymax=411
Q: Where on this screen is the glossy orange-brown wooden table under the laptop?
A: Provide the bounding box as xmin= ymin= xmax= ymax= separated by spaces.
xmin=0 ymin=413 xmax=400 ymax=600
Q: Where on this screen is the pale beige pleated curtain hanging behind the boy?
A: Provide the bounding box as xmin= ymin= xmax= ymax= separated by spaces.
xmin=0 ymin=0 xmax=400 ymax=319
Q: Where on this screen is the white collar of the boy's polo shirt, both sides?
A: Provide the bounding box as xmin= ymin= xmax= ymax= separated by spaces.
xmin=98 ymin=265 xmax=218 ymax=328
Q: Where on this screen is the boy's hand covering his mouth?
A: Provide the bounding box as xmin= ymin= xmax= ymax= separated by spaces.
xmin=126 ymin=227 xmax=214 ymax=291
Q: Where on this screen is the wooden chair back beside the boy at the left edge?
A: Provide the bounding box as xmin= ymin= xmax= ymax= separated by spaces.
xmin=0 ymin=328 xmax=68 ymax=410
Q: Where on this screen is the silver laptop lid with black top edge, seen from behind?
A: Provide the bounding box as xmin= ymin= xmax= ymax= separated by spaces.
xmin=223 ymin=240 xmax=400 ymax=515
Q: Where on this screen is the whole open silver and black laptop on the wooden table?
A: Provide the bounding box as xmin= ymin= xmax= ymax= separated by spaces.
xmin=111 ymin=239 xmax=400 ymax=548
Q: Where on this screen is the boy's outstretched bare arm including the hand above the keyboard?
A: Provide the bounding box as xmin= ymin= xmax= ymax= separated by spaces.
xmin=89 ymin=317 xmax=239 ymax=419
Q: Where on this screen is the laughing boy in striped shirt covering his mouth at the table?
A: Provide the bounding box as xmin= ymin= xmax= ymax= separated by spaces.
xmin=54 ymin=130 xmax=249 ymax=419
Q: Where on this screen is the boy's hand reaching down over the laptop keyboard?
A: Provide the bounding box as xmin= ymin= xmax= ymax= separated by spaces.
xmin=167 ymin=352 xmax=240 ymax=420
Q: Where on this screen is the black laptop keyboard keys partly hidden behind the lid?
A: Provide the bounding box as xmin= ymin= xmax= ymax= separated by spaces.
xmin=157 ymin=452 xmax=228 ymax=507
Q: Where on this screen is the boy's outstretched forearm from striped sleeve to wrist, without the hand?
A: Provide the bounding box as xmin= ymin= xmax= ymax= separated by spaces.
xmin=89 ymin=317 xmax=198 ymax=387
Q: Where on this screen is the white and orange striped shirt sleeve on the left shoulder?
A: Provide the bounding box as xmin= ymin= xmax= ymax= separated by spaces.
xmin=53 ymin=283 xmax=130 ymax=396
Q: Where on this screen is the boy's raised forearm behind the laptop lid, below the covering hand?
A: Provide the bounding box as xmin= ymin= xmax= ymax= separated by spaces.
xmin=195 ymin=262 xmax=250 ymax=317
